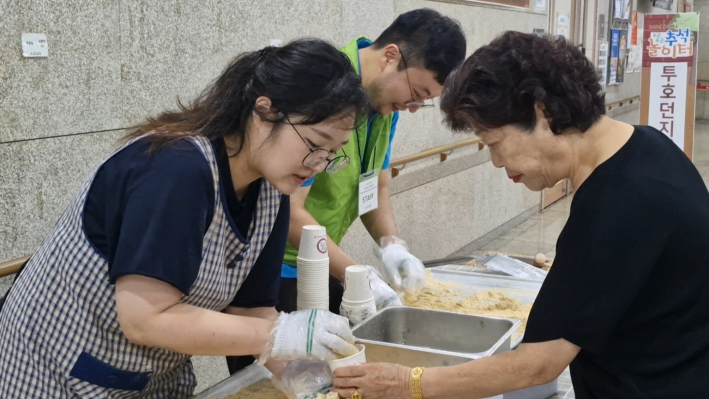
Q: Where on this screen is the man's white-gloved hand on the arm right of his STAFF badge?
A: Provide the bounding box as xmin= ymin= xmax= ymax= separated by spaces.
xmin=380 ymin=237 xmax=426 ymax=295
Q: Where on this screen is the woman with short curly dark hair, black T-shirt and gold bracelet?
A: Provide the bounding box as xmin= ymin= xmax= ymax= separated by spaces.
xmin=333 ymin=32 xmax=709 ymax=399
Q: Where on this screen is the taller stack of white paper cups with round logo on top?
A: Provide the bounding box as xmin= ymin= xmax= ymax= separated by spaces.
xmin=296 ymin=226 xmax=330 ymax=310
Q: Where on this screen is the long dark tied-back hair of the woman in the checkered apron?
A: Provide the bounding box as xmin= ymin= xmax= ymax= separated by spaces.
xmin=126 ymin=39 xmax=370 ymax=155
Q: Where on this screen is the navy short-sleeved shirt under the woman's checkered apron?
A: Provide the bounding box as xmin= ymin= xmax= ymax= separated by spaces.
xmin=83 ymin=140 xmax=290 ymax=307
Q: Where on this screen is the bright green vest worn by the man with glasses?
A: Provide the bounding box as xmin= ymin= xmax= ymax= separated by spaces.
xmin=283 ymin=37 xmax=394 ymax=266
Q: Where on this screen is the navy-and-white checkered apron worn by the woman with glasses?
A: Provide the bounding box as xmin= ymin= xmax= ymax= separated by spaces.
xmin=0 ymin=137 xmax=281 ymax=399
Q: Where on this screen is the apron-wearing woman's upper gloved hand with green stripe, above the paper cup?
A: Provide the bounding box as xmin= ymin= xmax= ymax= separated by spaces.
xmin=259 ymin=309 xmax=357 ymax=365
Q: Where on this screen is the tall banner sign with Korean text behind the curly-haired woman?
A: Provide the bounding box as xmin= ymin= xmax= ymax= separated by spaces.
xmin=640 ymin=13 xmax=699 ymax=159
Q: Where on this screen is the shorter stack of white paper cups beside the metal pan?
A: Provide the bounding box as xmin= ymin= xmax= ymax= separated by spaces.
xmin=340 ymin=266 xmax=377 ymax=324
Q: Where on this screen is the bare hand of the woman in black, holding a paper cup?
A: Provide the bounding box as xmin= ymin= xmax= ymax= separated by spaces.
xmin=332 ymin=363 xmax=411 ymax=399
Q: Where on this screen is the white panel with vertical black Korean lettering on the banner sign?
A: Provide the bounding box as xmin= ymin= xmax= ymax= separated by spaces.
xmin=648 ymin=62 xmax=687 ymax=151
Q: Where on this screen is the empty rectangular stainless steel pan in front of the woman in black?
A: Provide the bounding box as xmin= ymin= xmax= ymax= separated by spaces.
xmin=352 ymin=306 xmax=521 ymax=367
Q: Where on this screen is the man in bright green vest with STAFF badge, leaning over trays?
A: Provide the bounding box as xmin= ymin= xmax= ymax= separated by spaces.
xmin=279 ymin=9 xmax=466 ymax=313
